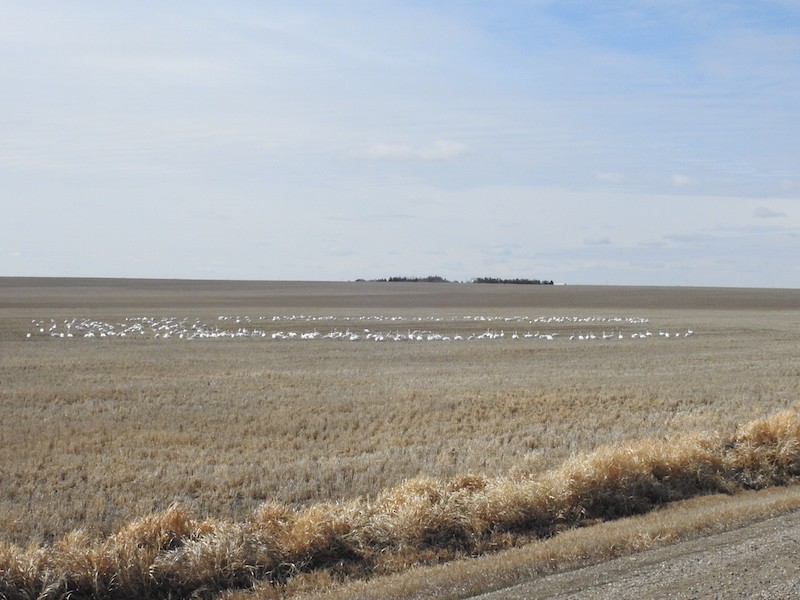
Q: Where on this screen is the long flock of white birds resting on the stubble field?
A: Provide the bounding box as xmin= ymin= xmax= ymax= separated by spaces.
xmin=26 ymin=315 xmax=694 ymax=342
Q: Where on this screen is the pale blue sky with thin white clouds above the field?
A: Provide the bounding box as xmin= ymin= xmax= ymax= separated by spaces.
xmin=0 ymin=0 xmax=800 ymax=288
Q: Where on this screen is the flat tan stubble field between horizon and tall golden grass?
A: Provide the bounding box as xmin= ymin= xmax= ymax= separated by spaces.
xmin=0 ymin=278 xmax=800 ymax=596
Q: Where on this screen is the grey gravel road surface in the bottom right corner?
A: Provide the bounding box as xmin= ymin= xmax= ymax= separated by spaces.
xmin=476 ymin=512 xmax=800 ymax=600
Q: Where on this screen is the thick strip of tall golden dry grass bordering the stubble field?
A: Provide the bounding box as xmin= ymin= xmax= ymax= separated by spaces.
xmin=0 ymin=411 xmax=800 ymax=599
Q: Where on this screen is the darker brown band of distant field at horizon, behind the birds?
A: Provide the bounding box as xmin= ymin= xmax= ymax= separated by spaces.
xmin=0 ymin=277 xmax=800 ymax=314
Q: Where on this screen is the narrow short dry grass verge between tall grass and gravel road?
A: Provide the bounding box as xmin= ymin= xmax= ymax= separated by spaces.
xmin=286 ymin=486 xmax=800 ymax=600
